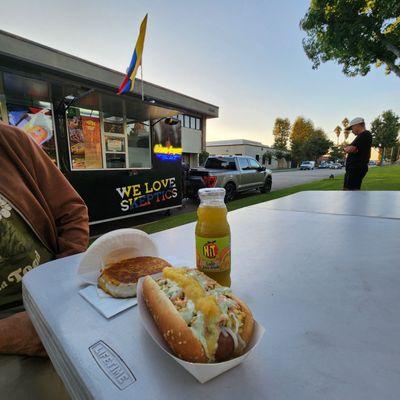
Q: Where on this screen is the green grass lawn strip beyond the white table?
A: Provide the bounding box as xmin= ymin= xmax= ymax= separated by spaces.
xmin=135 ymin=166 xmax=400 ymax=233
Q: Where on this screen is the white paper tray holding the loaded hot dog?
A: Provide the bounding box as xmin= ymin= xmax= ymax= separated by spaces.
xmin=137 ymin=274 xmax=265 ymax=383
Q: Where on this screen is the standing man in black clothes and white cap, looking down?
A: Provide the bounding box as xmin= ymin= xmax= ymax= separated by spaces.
xmin=343 ymin=118 xmax=372 ymax=190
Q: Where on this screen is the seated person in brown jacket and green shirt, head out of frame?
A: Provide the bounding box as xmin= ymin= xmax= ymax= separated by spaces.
xmin=0 ymin=122 xmax=89 ymax=355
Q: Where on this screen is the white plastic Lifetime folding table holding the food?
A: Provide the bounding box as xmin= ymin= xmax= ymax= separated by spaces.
xmin=18 ymin=192 xmax=400 ymax=400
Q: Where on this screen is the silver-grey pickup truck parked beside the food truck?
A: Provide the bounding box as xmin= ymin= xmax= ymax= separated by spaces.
xmin=186 ymin=156 xmax=272 ymax=201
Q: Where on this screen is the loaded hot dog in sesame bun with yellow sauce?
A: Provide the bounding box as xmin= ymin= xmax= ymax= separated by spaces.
xmin=142 ymin=267 xmax=254 ymax=363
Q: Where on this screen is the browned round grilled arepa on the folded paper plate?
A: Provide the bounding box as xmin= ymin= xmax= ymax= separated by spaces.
xmin=98 ymin=257 xmax=171 ymax=298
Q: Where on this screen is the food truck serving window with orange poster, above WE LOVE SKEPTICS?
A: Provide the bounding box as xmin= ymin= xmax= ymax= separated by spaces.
xmin=67 ymin=101 xmax=151 ymax=170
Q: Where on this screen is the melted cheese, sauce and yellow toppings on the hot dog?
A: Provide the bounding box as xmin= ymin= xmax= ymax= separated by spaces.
xmin=157 ymin=267 xmax=246 ymax=361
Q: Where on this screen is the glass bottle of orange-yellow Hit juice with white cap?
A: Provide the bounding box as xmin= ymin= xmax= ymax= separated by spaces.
xmin=196 ymin=188 xmax=231 ymax=287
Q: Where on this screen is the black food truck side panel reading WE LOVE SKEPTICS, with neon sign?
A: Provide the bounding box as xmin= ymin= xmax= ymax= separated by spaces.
xmin=66 ymin=121 xmax=182 ymax=222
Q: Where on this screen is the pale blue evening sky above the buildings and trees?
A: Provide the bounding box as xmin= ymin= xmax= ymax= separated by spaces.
xmin=0 ymin=0 xmax=400 ymax=145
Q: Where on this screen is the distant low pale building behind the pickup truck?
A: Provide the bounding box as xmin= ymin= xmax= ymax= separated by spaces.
xmin=206 ymin=139 xmax=290 ymax=169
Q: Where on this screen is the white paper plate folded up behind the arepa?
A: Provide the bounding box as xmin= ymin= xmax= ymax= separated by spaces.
xmin=78 ymin=229 xmax=158 ymax=285
